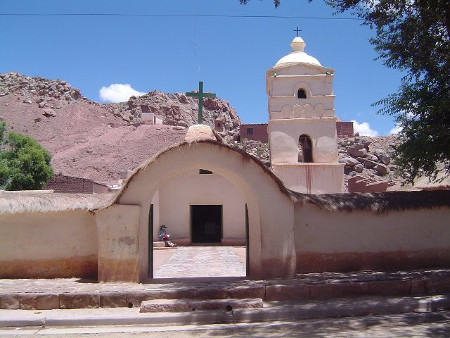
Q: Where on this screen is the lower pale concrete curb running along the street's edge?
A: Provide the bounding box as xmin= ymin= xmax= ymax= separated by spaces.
xmin=0 ymin=296 xmax=450 ymax=327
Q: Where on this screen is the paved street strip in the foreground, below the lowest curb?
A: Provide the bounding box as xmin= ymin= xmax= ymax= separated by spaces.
xmin=0 ymin=311 xmax=450 ymax=338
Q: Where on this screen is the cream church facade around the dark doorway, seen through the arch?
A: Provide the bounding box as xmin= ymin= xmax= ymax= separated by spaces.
xmin=153 ymin=168 xmax=245 ymax=243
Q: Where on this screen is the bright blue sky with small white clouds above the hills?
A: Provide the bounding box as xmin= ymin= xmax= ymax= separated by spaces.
xmin=0 ymin=0 xmax=402 ymax=136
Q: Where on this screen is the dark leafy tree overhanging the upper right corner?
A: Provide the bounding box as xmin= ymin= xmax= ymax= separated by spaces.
xmin=240 ymin=0 xmax=450 ymax=181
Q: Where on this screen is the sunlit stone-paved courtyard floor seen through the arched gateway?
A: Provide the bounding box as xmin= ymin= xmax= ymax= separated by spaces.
xmin=153 ymin=246 xmax=246 ymax=278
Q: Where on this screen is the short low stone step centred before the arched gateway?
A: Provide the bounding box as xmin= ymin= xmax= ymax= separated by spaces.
xmin=140 ymin=298 xmax=263 ymax=312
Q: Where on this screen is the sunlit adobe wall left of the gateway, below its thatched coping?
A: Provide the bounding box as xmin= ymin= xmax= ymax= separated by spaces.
xmin=0 ymin=210 xmax=97 ymax=278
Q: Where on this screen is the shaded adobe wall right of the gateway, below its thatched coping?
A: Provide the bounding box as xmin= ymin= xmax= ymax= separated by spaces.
xmin=295 ymin=203 xmax=450 ymax=273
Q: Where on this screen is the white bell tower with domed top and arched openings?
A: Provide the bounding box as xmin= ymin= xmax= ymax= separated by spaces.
xmin=266 ymin=37 xmax=344 ymax=194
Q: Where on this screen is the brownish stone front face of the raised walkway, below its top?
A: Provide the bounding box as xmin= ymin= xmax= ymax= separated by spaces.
xmin=0 ymin=277 xmax=450 ymax=310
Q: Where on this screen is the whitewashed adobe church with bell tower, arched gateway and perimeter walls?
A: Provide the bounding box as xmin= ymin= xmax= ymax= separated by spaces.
xmin=0 ymin=37 xmax=450 ymax=282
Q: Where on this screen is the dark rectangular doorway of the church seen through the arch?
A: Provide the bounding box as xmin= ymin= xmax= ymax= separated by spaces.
xmin=191 ymin=205 xmax=222 ymax=243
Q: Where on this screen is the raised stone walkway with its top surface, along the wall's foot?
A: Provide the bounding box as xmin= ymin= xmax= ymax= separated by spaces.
xmin=0 ymin=270 xmax=450 ymax=310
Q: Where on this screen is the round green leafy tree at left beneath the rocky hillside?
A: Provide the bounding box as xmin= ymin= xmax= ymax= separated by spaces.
xmin=0 ymin=122 xmax=53 ymax=190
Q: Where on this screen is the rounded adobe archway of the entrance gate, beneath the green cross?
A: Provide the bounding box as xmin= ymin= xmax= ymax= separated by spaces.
xmin=97 ymin=135 xmax=296 ymax=281
